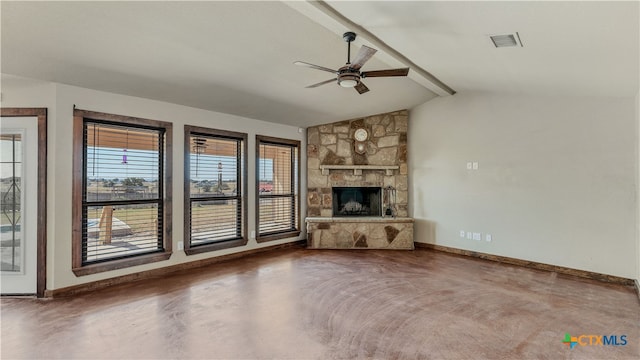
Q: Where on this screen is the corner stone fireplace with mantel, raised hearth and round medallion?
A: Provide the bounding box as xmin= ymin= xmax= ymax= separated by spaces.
xmin=306 ymin=110 xmax=413 ymax=249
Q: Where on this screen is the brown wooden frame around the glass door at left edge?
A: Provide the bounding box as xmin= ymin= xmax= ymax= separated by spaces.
xmin=0 ymin=108 xmax=47 ymax=297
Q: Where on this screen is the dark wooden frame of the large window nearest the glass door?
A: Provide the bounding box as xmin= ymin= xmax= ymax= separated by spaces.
xmin=72 ymin=109 xmax=173 ymax=276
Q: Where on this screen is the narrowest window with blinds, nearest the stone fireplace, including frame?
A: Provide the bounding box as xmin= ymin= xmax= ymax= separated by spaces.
xmin=256 ymin=135 xmax=300 ymax=242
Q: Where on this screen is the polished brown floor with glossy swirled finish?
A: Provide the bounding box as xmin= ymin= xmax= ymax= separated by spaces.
xmin=0 ymin=249 xmax=640 ymax=359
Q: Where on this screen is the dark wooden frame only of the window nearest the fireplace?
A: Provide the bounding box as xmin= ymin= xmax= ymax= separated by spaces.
xmin=255 ymin=135 xmax=301 ymax=243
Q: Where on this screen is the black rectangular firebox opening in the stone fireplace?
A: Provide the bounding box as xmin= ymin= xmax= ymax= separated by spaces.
xmin=331 ymin=187 xmax=382 ymax=216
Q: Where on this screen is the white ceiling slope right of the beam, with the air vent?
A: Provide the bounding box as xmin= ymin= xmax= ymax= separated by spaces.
xmin=328 ymin=1 xmax=640 ymax=96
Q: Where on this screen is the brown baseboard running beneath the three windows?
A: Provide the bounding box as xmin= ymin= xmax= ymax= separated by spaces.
xmin=44 ymin=239 xmax=307 ymax=298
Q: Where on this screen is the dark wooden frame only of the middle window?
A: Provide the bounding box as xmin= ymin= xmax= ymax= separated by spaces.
xmin=184 ymin=125 xmax=248 ymax=255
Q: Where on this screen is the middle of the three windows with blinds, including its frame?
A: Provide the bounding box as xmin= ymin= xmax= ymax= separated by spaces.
xmin=184 ymin=126 xmax=247 ymax=254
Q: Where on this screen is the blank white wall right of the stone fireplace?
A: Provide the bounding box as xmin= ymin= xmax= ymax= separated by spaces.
xmin=408 ymin=93 xmax=638 ymax=278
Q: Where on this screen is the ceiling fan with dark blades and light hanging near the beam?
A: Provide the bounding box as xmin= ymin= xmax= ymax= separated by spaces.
xmin=294 ymin=31 xmax=409 ymax=94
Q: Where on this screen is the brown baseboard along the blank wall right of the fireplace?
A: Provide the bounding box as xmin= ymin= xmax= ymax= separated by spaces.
xmin=415 ymin=242 xmax=640 ymax=286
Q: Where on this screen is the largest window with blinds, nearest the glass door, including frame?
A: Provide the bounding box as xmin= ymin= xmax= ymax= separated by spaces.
xmin=73 ymin=110 xmax=172 ymax=275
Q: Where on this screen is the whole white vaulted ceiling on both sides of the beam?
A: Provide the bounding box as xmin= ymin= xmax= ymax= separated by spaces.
xmin=0 ymin=1 xmax=640 ymax=127
